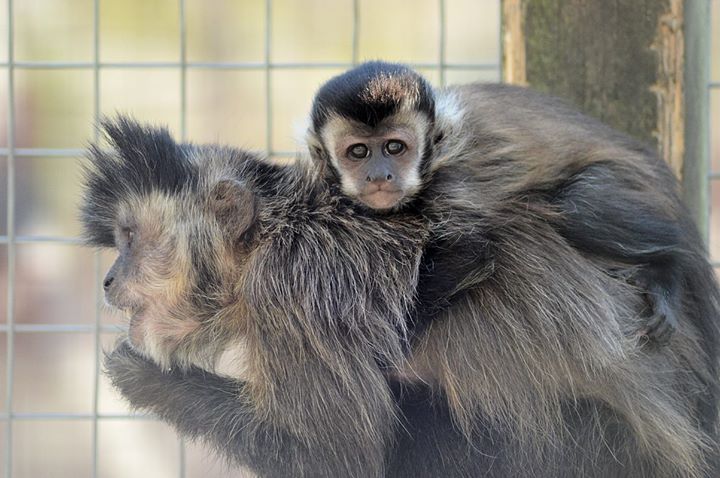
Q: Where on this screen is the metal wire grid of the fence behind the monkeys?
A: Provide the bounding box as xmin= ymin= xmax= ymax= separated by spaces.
xmin=0 ymin=0 xmax=499 ymax=478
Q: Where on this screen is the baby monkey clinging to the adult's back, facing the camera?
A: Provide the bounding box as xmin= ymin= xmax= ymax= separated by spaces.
xmin=307 ymin=61 xmax=682 ymax=344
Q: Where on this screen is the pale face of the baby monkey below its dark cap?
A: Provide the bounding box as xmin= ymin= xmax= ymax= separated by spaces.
xmin=323 ymin=114 xmax=429 ymax=211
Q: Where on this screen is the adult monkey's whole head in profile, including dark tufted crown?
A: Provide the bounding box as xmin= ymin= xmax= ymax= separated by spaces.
xmin=82 ymin=118 xmax=256 ymax=365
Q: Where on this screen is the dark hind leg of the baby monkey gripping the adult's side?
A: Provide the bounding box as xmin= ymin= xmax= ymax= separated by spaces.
xmin=552 ymin=164 xmax=683 ymax=344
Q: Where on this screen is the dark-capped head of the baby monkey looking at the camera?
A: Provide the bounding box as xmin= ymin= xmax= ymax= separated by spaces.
xmin=308 ymin=62 xmax=436 ymax=211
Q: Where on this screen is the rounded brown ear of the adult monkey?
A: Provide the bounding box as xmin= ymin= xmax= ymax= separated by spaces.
xmin=208 ymin=179 xmax=257 ymax=241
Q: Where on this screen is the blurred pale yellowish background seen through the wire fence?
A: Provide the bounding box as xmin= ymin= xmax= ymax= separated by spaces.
xmin=0 ymin=0 xmax=720 ymax=478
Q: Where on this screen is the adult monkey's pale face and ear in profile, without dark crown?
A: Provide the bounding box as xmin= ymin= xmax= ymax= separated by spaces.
xmin=103 ymin=180 xmax=255 ymax=364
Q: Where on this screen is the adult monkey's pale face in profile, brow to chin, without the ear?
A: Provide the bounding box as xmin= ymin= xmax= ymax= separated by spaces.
xmin=103 ymin=190 xmax=194 ymax=350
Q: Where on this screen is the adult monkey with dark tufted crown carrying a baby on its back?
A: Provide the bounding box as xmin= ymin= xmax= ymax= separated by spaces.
xmin=90 ymin=116 xmax=718 ymax=478
